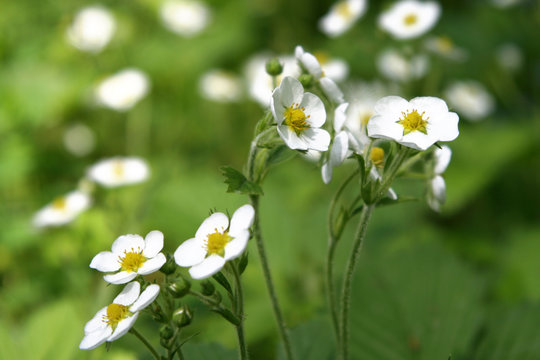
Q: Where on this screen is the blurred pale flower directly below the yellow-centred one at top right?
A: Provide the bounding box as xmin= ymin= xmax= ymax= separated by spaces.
xmin=377 ymin=49 xmax=429 ymax=82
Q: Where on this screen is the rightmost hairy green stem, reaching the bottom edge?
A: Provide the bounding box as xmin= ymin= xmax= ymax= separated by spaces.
xmin=339 ymin=204 xmax=375 ymax=360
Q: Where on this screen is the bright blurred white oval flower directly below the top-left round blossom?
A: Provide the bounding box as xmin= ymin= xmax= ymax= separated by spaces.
xmin=95 ymin=69 xmax=150 ymax=111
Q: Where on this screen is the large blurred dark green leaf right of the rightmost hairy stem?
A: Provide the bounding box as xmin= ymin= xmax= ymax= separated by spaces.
xmin=349 ymin=244 xmax=482 ymax=360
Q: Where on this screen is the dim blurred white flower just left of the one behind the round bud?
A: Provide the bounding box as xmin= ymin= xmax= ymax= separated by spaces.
xmin=199 ymin=69 xmax=242 ymax=102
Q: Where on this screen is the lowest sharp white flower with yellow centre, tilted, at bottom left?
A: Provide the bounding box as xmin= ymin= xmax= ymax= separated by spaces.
xmin=79 ymin=281 xmax=159 ymax=350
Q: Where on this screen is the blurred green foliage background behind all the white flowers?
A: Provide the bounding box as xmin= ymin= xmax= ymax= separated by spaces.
xmin=0 ymin=0 xmax=540 ymax=360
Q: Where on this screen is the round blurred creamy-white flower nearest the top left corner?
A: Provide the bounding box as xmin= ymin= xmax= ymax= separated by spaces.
xmin=67 ymin=6 xmax=116 ymax=53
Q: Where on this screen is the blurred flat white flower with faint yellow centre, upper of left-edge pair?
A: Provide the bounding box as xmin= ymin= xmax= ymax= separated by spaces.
xmin=87 ymin=157 xmax=150 ymax=187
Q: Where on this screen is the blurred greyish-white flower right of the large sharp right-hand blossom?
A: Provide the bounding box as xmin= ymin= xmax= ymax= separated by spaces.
xmin=444 ymin=80 xmax=495 ymax=121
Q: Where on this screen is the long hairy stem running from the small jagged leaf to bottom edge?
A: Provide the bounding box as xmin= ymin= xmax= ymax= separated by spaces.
xmin=249 ymin=195 xmax=294 ymax=360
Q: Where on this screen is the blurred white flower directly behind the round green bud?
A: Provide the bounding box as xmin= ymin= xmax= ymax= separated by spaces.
xmin=244 ymin=54 xmax=300 ymax=107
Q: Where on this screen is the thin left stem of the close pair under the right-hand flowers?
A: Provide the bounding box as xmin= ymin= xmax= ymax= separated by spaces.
xmin=326 ymin=169 xmax=360 ymax=342
